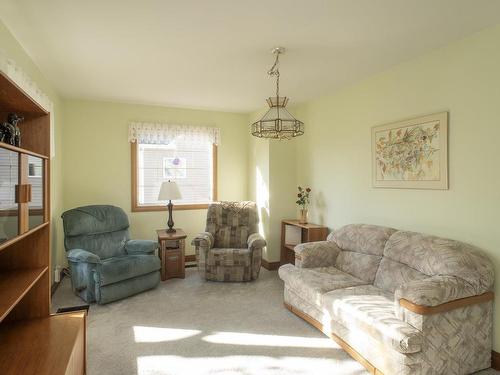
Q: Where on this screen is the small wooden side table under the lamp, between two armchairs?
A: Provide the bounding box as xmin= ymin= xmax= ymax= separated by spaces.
xmin=156 ymin=228 xmax=187 ymax=281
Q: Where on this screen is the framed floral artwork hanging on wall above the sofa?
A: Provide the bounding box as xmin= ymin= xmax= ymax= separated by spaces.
xmin=372 ymin=112 xmax=448 ymax=190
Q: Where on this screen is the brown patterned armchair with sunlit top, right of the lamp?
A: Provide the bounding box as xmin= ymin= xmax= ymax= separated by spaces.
xmin=192 ymin=202 xmax=266 ymax=281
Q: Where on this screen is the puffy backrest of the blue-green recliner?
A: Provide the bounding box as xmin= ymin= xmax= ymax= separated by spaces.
xmin=61 ymin=205 xmax=130 ymax=259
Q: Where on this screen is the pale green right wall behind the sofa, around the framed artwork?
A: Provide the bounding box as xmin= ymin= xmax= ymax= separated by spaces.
xmin=297 ymin=25 xmax=500 ymax=351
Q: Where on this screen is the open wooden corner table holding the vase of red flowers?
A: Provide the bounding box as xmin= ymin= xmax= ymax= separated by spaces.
xmin=280 ymin=220 xmax=328 ymax=265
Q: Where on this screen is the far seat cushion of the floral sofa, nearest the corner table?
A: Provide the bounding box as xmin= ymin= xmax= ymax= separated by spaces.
xmin=278 ymin=264 xmax=366 ymax=307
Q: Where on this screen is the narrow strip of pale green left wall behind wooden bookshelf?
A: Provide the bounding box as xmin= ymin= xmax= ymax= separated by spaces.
xmin=0 ymin=21 xmax=64 ymax=277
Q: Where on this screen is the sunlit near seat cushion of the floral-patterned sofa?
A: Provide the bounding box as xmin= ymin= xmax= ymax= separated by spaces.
xmin=323 ymin=285 xmax=422 ymax=353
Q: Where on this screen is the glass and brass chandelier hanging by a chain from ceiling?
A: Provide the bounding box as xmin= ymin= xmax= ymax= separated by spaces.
xmin=251 ymin=47 xmax=304 ymax=139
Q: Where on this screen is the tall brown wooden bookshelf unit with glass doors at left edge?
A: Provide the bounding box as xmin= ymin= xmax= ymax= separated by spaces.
xmin=0 ymin=73 xmax=86 ymax=375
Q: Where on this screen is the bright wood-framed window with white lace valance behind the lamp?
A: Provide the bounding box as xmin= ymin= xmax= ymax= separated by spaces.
xmin=129 ymin=124 xmax=218 ymax=211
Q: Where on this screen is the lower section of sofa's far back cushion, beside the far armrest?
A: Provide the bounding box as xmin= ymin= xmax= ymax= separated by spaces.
xmin=335 ymin=251 xmax=382 ymax=284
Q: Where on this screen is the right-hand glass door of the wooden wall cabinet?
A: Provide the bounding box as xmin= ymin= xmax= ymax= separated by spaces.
xmin=28 ymin=155 xmax=45 ymax=229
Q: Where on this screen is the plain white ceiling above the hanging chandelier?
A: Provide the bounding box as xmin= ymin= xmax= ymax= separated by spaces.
xmin=0 ymin=0 xmax=500 ymax=111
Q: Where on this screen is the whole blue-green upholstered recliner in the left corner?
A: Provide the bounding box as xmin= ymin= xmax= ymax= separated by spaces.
xmin=61 ymin=205 xmax=161 ymax=304
